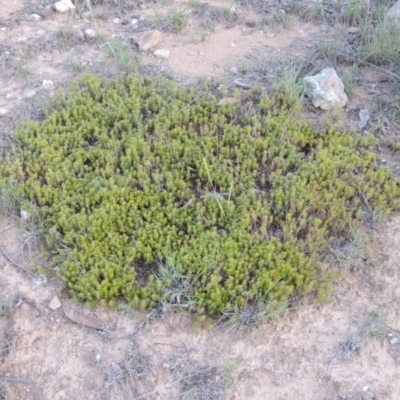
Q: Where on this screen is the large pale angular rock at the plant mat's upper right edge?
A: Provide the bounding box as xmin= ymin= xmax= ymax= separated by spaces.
xmin=304 ymin=67 xmax=348 ymax=110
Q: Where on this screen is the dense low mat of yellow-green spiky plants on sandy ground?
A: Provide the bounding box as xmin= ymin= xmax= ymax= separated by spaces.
xmin=2 ymin=76 xmax=400 ymax=315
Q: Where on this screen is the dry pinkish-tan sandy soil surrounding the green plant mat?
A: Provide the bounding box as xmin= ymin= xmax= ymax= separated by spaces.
xmin=0 ymin=0 xmax=400 ymax=400
